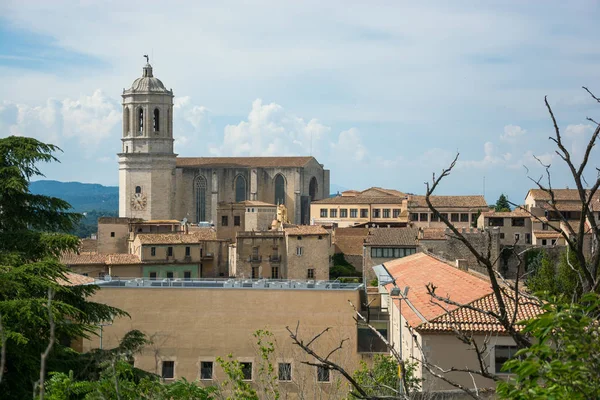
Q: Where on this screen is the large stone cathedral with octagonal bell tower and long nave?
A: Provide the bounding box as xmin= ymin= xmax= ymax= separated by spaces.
xmin=118 ymin=62 xmax=329 ymax=224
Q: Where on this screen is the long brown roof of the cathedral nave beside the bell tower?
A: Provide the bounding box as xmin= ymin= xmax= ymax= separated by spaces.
xmin=177 ymin=157 xmax=316 ymax=168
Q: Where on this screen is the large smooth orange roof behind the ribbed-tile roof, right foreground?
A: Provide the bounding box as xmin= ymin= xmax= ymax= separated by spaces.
xmin=385 ymin=253 xmax=492 ymax=327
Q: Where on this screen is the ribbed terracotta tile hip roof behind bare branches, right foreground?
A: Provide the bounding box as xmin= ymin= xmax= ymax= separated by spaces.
xmin=416 ymin=293 xmax=542 ymax=333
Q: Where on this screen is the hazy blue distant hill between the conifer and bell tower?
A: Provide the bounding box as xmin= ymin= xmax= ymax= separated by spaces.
xmin=29 ymin=180 xmax=119 ymax=212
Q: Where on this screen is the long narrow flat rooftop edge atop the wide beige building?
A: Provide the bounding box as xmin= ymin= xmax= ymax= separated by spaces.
xmin=89 ymin=277 xmax=363 ymax=291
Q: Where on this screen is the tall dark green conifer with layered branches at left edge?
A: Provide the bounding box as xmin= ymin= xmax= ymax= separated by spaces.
xmin=0 ymin=136 xmax=125 ymax=399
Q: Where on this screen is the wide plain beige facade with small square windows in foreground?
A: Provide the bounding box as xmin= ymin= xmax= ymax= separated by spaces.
xmin=82 ymin=280 xmax=368 ymax=399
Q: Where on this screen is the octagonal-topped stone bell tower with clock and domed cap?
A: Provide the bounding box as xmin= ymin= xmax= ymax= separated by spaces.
xmin=118 ymin=56 xmax=177 ymax=220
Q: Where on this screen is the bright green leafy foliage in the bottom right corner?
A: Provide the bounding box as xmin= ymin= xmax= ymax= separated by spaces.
xmin=498 ymin=293 xmax=600 ymax=400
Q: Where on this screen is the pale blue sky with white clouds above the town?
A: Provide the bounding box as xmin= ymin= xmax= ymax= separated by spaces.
xmin=0 ymin=0 xmax=600 ymax=203
